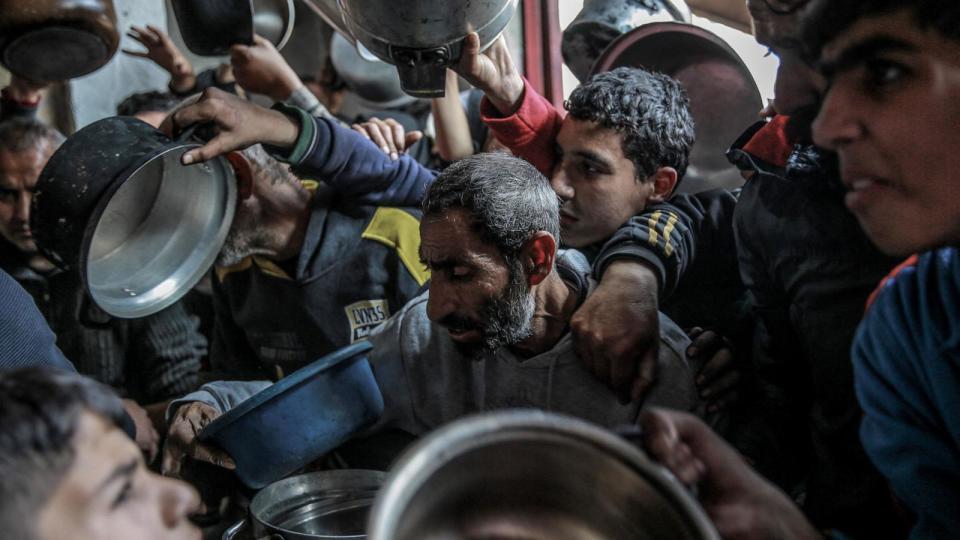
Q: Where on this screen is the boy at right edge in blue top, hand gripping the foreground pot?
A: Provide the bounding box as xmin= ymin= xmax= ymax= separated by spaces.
xmin=644 ymin=0 xmax=960 ymax=539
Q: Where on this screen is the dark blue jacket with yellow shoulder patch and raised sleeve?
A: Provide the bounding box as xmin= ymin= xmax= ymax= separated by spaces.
xmin=211 ymin=114 xmax=434 ymax=378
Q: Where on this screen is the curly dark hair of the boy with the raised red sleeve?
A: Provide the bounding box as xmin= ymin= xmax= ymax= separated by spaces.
xmin=564 ymin=67 xmax=695 ymax=180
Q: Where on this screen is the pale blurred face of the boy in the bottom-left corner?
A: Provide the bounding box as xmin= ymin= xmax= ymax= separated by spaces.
xmin=37 ymin=412 xmax=200 ymax=540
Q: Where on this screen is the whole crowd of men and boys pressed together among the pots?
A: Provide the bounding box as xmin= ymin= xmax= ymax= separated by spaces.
xmin=0 ymin=0 xmax=960 ymax=540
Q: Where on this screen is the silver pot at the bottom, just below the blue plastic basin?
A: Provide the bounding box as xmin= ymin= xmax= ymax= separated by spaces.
xmin=223 ymin=470 xmax=386 ymax=540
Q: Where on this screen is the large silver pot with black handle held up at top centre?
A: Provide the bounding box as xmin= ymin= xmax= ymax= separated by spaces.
xmin=338 ymin=0 xmax=517 ymax=98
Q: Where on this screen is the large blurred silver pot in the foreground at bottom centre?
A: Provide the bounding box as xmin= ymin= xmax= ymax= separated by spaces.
xmin=368 ymin=410 xmax=719 ymax=540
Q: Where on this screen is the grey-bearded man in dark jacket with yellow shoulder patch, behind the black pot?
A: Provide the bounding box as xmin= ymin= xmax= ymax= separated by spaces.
xmin=204 ymin=141 xmax=428 ymax=379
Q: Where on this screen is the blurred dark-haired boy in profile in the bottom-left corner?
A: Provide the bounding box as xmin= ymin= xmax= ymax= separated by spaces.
xmin=0 ymin=369 xmax=200 ymax=540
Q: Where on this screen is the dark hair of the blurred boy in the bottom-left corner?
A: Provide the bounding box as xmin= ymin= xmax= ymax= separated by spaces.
xmin=0 ymin=368 xmax=124 ymax=539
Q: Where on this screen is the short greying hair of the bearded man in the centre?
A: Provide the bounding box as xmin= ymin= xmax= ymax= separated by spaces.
xmin=422 ymin=153 xmax=560 ymax=261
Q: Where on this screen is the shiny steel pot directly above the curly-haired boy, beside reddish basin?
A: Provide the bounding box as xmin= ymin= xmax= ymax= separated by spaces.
xmin=560 ymin=0 xmax=692 ymax=81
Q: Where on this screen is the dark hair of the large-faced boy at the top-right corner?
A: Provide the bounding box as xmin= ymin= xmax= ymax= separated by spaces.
xmin=803 ymin=0 xmax=960 ymax=60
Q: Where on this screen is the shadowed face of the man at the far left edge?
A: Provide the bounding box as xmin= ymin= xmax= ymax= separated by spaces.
xmin=0 ymin=144 xmax=53 ymax=255
